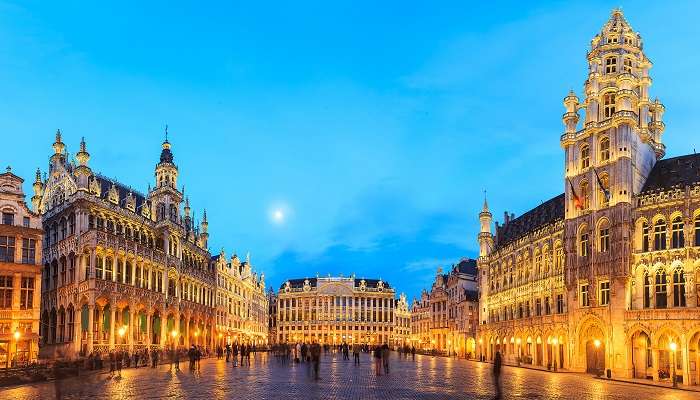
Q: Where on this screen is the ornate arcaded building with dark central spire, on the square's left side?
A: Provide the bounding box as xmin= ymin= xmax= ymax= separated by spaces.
xmin=37 ymin=131 xmax=266 ymax=357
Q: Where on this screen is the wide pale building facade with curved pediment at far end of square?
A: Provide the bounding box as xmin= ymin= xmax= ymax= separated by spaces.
xmin=277 ymin=277 xmax=395 ymax=345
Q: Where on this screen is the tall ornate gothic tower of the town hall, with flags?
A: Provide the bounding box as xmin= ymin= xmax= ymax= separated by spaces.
xmin=561 ymin=9 xmax=665 ymax=371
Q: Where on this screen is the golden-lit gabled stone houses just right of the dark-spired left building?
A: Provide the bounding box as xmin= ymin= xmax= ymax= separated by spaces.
xmin=212 ymin=250 xmax=268 ymax=346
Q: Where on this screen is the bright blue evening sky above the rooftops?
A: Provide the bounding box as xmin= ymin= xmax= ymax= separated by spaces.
xmin=0 ymin=0 xmax=700 ymax=299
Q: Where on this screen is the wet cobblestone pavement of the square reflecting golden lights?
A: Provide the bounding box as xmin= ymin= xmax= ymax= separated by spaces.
xmin=0 ymin=354 xmax=700 ymax=400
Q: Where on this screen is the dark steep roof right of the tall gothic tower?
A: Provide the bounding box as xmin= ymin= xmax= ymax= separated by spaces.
xmin=642 ymin=154 xmax=700 ymax=193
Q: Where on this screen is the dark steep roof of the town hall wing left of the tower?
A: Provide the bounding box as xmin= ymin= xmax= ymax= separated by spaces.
xmin=496 ymin=193 xmax=564 ymax=248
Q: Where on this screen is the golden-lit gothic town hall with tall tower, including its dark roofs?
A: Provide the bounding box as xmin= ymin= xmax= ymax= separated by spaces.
xmin=479 ymin=10 xmax=700 ymax=384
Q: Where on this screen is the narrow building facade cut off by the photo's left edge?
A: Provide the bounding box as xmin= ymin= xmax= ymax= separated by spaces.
xmin=0 ymin=167 xmax=43 ymax=368
